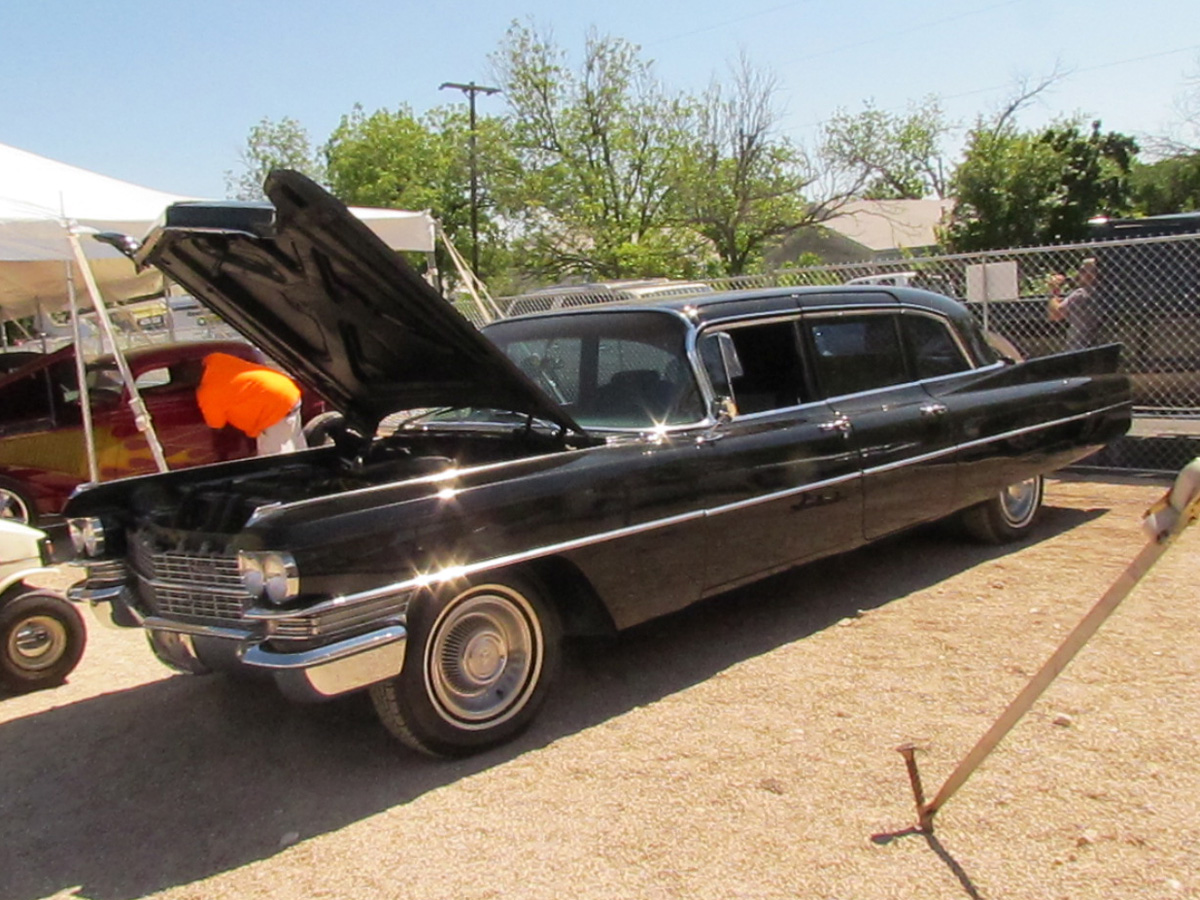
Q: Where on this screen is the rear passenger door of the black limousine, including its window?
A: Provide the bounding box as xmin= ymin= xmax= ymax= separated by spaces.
xmin=804 ymin=306 xmax=958 ymax=540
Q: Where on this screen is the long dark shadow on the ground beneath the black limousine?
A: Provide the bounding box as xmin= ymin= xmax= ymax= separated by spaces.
xmin=0 ymin=506 xmax=1104 ymax=900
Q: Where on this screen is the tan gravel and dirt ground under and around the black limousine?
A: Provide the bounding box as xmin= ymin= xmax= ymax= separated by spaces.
xmin=0 ymin=480 xmax=1200 ymax=900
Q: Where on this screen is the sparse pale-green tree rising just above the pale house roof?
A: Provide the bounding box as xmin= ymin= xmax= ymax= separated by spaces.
xmin=822 ymin=97 xmax=949 ymax=199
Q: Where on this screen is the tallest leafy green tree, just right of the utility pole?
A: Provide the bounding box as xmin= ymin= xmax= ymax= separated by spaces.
xmin=492 ymin=23 xmax=698 ymax=278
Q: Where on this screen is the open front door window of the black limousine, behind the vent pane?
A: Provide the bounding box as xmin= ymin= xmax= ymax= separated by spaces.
xmin=710 ymin=322 xmax=808 ymax=415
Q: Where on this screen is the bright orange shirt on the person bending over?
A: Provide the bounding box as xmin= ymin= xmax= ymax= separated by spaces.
xmin=196 ymin=353 xmax=300 ymax=438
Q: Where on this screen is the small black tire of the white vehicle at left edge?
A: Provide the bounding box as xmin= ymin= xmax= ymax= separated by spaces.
xmin=0 ymin=588 xmax=88 ymax=694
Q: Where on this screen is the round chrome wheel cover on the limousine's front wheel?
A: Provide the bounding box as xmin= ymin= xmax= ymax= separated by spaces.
xmin=425 ymin=584 xmax=545 ymax=731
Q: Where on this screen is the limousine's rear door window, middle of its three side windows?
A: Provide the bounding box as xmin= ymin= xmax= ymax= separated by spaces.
xmin=808 ymin=313 xmax=908 ymax=397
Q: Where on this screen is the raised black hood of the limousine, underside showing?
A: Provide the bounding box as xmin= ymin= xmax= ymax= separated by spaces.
xmin=133 ymin=170 xmax=582 ymax=434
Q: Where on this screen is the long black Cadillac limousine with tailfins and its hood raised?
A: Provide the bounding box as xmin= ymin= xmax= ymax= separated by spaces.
xmin=66 ymin=172 xmax=1130 ymax=755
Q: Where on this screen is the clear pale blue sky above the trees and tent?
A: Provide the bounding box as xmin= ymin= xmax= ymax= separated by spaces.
xmin=0 ymin=0 xmax=1200 ymax=197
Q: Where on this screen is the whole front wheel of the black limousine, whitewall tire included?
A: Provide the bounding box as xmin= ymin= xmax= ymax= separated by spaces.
xmin=371 ymin=576 xmax=560 ymax=756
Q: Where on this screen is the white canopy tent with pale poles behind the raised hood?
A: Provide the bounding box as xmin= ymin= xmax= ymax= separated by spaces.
xmin=0 ymin=144 xmax=436 ymax=481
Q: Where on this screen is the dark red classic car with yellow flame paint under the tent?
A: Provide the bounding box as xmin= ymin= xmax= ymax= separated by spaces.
xmin=0 ymin=341 xmax=313 ymax=524
